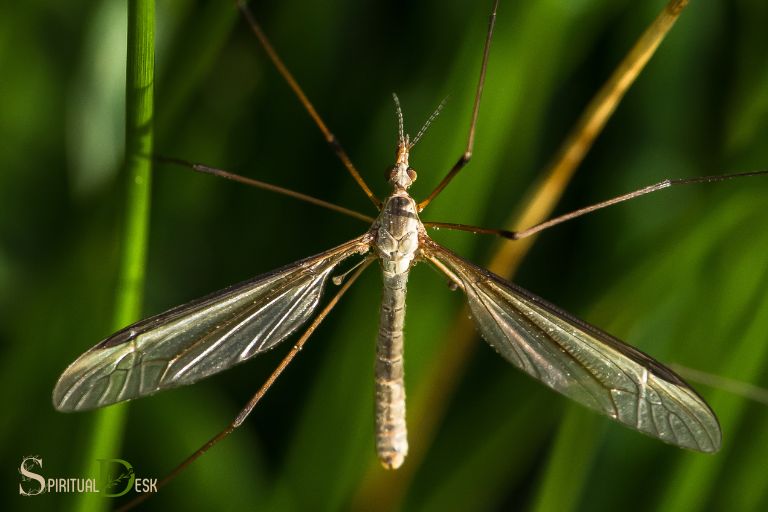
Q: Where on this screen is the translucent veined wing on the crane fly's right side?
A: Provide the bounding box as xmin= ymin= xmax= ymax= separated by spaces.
xmin=424 ymin=240 xmax=721 ymax=452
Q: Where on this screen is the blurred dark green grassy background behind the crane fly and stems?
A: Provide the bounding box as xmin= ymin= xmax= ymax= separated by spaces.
xmin=0 ymin=0 xmax=768 ymax=511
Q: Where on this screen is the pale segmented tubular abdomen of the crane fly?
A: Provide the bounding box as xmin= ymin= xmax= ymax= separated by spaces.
xmin=376 ymin=273 xmax=408 ymax=469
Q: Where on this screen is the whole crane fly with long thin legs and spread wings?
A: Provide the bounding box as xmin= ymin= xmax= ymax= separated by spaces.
xmin=53 ymin=1 xmax=765 ymax=484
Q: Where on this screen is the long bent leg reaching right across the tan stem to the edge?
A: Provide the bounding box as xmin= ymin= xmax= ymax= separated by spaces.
xmin=424 ymin=170 xmax=768 ymax=240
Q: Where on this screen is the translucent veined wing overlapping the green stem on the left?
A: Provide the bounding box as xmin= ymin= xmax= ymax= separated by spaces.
xmin=53 ymin=235 xmax=369 ymax=411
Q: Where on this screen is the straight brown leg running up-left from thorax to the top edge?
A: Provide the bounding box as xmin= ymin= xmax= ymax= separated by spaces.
xmin=232 ymin=0 xmax=381 ymax=209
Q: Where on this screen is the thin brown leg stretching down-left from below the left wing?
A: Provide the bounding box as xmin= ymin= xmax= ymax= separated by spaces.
xmin=117 ymin=260 xmax=373 ymax=511
